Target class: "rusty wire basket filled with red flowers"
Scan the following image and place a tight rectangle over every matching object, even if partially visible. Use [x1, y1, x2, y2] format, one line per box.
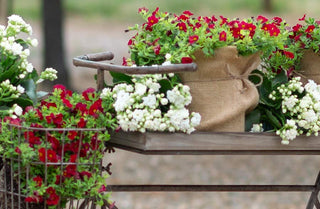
[0, 125, 110, 209]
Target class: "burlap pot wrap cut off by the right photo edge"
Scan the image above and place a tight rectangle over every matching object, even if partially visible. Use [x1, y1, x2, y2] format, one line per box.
[296, 50, 320, 84]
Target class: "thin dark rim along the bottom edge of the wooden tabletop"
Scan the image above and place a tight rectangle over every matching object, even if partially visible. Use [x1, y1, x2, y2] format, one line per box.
[108, 142, 320, 155]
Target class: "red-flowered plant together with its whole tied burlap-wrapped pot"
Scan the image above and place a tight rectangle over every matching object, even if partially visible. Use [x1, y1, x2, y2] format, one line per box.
[124, 8, 289, 131]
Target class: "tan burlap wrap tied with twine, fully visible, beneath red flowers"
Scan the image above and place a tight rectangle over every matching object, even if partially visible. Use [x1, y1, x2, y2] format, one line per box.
[180, 47, 260, 132]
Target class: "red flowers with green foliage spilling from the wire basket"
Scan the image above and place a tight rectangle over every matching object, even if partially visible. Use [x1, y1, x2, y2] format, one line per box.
[0, 85, 116, 208]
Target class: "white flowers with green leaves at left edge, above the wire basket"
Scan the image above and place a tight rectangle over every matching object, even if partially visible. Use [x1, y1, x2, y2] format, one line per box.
[0, 15, 57, 117]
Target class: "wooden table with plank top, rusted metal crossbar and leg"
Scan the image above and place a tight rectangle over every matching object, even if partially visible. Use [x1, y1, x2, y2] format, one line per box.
[108, 132, 320, 209]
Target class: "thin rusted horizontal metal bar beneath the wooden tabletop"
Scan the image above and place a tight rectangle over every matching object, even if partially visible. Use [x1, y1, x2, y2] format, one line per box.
[107, 184, 315, 192]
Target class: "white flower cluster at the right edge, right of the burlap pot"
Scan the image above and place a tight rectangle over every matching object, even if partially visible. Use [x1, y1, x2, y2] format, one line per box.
[269, 77, 320, 144]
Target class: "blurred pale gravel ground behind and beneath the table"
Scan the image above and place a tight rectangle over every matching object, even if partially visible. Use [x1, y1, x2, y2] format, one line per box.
[28, 19, 320, 209]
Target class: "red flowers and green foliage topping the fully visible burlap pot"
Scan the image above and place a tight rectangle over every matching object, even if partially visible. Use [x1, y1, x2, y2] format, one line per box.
[125, 8, 289, 66]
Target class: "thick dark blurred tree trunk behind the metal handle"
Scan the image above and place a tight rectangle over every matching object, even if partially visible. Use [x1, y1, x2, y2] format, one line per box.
[42, 0, 70, 90]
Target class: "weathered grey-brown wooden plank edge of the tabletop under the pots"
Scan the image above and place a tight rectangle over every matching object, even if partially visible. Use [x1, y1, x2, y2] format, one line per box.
[110, 132, 320, 154]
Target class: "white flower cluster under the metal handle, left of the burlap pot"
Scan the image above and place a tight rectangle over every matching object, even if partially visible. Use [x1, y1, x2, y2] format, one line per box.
[101, 74, 201, 133]
